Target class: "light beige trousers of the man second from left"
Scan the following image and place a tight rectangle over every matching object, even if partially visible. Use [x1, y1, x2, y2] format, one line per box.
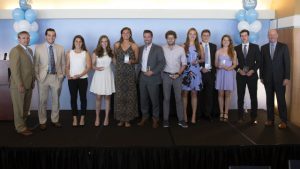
[38, 74, 62, 124]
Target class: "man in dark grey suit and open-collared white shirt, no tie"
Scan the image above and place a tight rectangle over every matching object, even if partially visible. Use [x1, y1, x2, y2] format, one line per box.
[138, 30, 166, 128]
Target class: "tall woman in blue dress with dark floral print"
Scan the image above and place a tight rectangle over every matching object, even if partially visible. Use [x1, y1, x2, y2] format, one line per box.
[182, 28, 204, 124]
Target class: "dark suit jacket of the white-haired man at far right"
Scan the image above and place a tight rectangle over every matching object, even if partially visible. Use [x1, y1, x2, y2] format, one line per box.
[260, 42, 290, 84]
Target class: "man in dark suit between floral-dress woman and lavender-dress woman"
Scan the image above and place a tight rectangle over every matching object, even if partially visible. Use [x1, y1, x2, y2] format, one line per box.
[198, 29, 219, 121]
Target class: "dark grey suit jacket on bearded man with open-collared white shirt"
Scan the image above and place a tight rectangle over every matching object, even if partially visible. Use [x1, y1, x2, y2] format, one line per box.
[138, 43, 166, 84]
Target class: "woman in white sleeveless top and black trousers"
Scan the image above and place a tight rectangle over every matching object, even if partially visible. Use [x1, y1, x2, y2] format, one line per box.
[66, 35, 91, 127]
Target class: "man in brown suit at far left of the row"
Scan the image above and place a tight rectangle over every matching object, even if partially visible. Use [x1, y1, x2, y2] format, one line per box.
[9, 31, 35, 136]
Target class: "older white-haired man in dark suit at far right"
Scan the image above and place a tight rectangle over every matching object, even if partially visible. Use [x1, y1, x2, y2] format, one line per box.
[260, 29, 290, 129]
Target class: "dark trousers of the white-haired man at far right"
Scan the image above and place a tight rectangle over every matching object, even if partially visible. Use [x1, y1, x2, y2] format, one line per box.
[264, 79, 287, 123]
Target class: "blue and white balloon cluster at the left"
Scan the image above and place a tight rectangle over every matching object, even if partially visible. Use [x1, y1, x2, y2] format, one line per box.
[12, 0, 39, 45]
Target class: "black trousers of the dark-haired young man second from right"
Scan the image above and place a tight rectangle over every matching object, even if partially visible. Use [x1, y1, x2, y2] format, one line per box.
[236, 73, 258, 119]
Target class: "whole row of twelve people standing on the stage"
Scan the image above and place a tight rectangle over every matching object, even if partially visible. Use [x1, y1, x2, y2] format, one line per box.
[10, 27, 290, 136]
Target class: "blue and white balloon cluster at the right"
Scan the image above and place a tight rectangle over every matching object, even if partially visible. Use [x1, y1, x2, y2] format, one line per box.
[234, 0, 262, 43]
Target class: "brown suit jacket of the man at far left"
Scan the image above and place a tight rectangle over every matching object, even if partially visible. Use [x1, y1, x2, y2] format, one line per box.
[9, 45, 35, 89]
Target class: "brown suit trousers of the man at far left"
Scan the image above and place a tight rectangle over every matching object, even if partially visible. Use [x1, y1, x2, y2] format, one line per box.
[10, 88, 32, 132]
